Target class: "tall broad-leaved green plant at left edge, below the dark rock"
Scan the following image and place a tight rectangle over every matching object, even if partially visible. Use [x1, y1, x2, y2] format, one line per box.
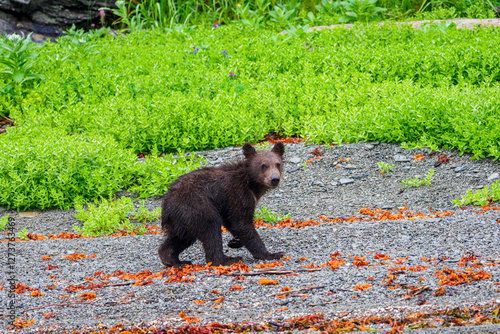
[0, 34, 44, 91]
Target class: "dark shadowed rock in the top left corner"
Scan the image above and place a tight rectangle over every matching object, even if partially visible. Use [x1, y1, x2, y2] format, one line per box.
[0, 0, 115, 42]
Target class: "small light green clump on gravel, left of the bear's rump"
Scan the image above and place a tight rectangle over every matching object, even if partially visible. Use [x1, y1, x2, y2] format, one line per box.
[73, 197, 134, 236]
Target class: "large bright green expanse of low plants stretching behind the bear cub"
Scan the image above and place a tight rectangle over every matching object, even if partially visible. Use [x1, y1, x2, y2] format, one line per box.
[14, 26, 500, 158]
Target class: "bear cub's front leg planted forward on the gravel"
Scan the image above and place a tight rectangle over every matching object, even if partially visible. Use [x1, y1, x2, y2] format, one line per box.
[229, 223, 285, 260]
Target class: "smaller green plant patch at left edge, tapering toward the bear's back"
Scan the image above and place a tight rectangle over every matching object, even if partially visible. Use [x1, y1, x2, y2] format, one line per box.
[0, 127, 201, 209]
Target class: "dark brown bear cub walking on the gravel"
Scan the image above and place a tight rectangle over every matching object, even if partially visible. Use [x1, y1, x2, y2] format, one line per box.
[158, 142, 285, 266]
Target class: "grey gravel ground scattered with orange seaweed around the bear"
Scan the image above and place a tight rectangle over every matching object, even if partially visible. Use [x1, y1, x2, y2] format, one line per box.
[0, 143, 500, 333]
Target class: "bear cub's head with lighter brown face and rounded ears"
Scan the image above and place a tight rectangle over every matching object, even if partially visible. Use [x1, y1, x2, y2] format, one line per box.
[243, 142, 285, 189]
